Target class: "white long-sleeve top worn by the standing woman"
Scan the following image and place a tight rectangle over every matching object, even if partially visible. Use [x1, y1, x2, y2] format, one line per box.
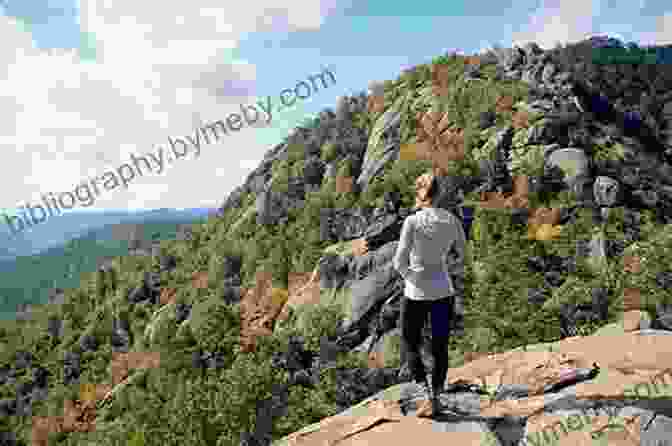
[392, 208, 466, 300]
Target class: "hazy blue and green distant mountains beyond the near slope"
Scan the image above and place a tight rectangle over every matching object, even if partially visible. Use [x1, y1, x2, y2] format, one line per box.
[0, 208, 216, 319]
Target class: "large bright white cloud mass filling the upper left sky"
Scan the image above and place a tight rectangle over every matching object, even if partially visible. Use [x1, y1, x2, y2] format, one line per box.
[0, 0, 334, 213]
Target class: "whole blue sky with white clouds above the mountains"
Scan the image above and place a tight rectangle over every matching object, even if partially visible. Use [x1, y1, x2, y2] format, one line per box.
[0, 0, 672, 219]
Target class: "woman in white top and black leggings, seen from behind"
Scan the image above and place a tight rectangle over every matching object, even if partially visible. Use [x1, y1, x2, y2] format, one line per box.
[393, 173, 466, 414]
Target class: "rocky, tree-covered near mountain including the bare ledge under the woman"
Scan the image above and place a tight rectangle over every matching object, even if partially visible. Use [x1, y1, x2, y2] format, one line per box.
[0, 35, 672, 446]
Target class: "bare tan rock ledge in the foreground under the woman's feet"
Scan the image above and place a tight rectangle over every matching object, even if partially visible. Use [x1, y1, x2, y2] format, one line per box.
[274, 330, 672, 446]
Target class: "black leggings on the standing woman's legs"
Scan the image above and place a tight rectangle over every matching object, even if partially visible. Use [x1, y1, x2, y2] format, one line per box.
[401, 296, 455, 389]
